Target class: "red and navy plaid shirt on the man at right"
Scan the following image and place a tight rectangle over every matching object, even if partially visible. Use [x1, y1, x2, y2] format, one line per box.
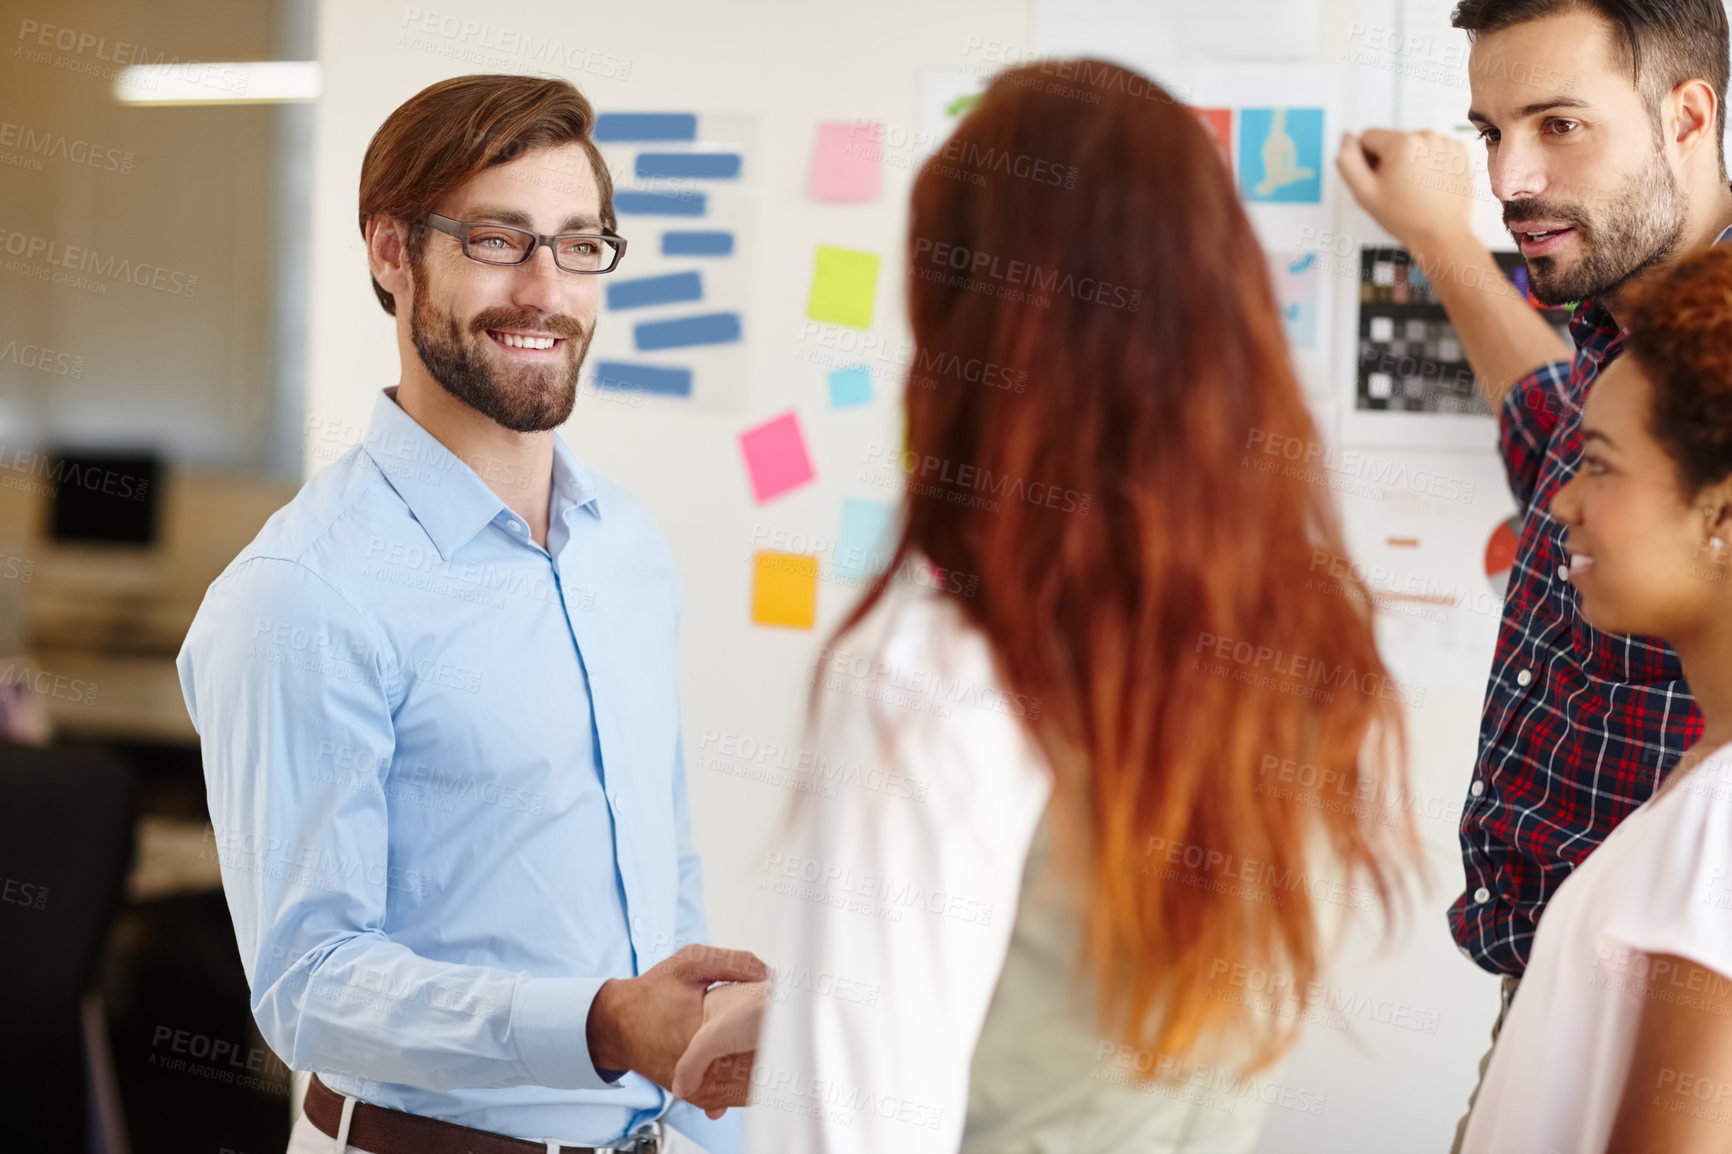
[1450, 229, 1732, 976]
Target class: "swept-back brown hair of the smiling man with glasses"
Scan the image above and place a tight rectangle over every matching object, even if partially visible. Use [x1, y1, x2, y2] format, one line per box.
[360, 75, 615, 317]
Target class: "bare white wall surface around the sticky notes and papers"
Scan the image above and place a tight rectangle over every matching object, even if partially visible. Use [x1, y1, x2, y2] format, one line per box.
[307, 0, 1509, 1154]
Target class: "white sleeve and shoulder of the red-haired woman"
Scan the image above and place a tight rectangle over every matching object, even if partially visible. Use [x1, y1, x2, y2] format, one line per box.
[748, 587, 1051, 1154]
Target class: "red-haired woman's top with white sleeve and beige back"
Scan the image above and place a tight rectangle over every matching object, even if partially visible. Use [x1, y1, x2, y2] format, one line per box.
[748, 589, 1268, 1154]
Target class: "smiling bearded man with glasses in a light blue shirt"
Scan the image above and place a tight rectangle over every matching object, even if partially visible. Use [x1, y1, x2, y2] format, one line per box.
[178, 76, 767, 1154]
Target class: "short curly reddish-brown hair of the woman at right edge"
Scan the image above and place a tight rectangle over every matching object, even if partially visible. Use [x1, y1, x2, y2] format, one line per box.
[1618, 244, 1732, 499]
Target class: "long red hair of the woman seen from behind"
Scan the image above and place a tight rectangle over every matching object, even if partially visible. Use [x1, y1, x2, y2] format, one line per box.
[837, 61, 1417, 1069]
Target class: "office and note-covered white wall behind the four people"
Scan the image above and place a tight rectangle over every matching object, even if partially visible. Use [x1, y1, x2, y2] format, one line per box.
[10, 0, 1718, 1154]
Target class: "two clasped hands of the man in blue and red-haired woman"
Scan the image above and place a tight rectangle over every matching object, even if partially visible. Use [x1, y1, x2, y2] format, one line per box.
[585, 946, 769, 1118]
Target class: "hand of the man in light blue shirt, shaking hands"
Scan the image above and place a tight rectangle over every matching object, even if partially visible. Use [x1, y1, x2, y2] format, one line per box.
[585, 946, 769, 1109]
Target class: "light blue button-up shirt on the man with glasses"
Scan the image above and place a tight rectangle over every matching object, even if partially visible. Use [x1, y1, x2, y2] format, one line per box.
[178, 390, 740, 1152]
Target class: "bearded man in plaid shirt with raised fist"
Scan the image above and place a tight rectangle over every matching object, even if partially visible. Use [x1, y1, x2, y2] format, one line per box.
[1335, 0, 1732, 1145]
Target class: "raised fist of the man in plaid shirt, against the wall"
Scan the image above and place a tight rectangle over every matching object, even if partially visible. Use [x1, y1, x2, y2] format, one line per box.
[1335, 128, 1474, 253]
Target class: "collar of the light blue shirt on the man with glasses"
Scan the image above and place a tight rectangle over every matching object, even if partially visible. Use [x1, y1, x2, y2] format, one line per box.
[362, 385, 601, 561]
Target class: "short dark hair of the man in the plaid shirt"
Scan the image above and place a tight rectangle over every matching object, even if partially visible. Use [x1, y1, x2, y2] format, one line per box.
[1450, 0, 1729, 177]
